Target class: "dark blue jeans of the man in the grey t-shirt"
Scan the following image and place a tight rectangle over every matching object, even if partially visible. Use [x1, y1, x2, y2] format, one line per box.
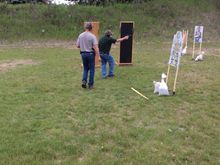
[80, 52, 95, 86]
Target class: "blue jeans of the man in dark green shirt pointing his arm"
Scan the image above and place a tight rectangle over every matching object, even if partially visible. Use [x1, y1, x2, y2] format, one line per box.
[100, 53, 115, 78]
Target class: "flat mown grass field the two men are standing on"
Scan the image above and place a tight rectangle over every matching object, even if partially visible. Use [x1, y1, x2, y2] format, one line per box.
[0, 41, 220, 165]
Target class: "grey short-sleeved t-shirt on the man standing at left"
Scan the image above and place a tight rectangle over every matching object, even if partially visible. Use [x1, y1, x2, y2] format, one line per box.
[76, 31, 98, 52]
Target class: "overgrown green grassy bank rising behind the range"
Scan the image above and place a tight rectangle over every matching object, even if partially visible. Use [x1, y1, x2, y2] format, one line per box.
[0, 0, 220, 42]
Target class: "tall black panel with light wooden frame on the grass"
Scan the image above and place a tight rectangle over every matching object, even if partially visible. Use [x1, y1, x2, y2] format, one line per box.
[119, 21, 134, 65]
